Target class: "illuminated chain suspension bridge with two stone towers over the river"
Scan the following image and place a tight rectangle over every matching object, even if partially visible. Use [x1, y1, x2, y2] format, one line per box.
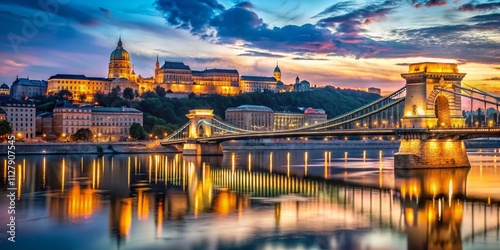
[161, 62, 500, 169]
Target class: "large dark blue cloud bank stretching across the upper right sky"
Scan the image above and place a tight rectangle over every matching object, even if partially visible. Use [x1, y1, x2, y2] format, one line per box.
[156, 0, 500, 63]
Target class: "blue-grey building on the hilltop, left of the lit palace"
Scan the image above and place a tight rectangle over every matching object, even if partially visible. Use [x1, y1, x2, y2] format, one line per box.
[10, 77, 47, 100]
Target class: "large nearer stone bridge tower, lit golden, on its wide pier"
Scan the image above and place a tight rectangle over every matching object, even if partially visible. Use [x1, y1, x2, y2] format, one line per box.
[394, 62, 470, 169]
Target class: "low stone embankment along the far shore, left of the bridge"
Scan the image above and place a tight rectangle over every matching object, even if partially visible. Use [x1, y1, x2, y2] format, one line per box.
[0, 141, 177, 155]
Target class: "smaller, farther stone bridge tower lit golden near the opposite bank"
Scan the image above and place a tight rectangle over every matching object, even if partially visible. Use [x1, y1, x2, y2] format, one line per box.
[183, 109, 222, 155]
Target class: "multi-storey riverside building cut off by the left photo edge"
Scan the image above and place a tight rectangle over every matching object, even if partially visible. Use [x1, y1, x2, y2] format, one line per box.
[0, 95, 36, 139]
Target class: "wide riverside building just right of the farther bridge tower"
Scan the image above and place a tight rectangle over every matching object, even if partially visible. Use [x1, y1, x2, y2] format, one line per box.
[225, 105, 274, 131]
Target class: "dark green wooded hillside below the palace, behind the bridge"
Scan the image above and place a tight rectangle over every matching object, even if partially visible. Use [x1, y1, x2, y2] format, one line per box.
[131, 88, 380, 131]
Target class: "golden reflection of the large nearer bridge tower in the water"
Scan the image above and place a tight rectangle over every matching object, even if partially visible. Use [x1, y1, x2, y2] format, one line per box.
[395, 168, 469, 249]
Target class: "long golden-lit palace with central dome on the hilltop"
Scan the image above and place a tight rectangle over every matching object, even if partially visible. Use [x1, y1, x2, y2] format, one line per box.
[47, 38, 310, 98]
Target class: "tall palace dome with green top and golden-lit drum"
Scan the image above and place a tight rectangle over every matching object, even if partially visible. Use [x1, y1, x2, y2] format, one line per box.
[108, 37, 131, 79]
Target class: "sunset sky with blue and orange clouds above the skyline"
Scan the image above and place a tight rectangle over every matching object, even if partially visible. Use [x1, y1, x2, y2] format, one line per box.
[0, 0, 500, 94]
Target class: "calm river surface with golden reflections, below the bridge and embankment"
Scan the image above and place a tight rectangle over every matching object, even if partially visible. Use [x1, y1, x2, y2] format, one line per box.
[0, 150, 500, 249]
